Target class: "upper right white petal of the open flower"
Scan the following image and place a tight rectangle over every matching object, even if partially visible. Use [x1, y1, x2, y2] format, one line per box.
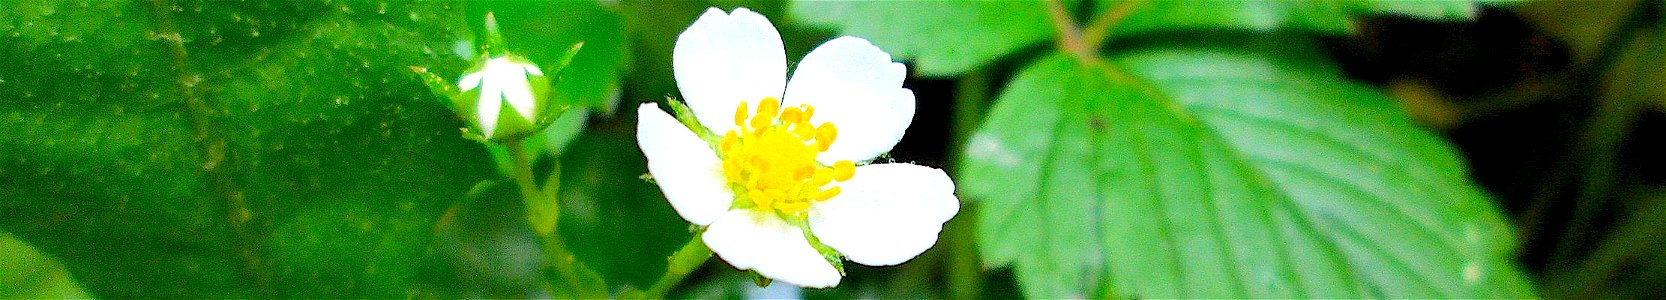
[781, 37, 915, 165]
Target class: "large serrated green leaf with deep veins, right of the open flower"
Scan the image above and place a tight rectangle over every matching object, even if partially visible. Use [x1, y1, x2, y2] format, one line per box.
[958, 38, 1533, 298]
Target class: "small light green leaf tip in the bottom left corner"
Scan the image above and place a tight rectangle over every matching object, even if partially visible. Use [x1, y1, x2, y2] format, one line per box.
[0, 232, 90, 298]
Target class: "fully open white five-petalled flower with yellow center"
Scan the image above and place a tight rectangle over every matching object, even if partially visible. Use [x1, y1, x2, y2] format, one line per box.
[636, 8, 960, 287]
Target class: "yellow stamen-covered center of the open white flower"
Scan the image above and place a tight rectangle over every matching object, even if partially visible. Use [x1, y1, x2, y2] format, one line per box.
[721, 98, 856, 215]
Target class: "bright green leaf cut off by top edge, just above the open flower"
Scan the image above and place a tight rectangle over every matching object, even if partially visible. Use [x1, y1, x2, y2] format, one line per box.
[791, 2, 1056, 77]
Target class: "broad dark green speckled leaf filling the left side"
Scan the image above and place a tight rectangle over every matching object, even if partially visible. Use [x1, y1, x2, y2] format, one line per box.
[0, 0, 495, 298]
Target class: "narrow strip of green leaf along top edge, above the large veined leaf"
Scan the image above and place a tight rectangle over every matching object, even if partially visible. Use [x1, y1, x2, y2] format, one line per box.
[1096, 0, 1479, 37]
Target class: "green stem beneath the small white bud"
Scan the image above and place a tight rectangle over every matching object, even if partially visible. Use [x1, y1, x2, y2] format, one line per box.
[503, 138, 606, 298]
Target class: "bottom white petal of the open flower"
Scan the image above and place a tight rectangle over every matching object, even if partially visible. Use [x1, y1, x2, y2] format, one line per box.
[701, 210, 840, 288]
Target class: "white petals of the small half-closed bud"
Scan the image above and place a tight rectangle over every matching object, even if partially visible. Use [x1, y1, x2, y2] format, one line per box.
[456, 57, 543, 138]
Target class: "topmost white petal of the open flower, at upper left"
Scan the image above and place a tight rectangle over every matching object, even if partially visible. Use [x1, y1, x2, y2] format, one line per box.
[671, 8, 786, 135]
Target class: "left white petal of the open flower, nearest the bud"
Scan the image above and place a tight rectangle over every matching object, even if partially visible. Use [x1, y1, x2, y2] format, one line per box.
[636, 103, 735, 225]
